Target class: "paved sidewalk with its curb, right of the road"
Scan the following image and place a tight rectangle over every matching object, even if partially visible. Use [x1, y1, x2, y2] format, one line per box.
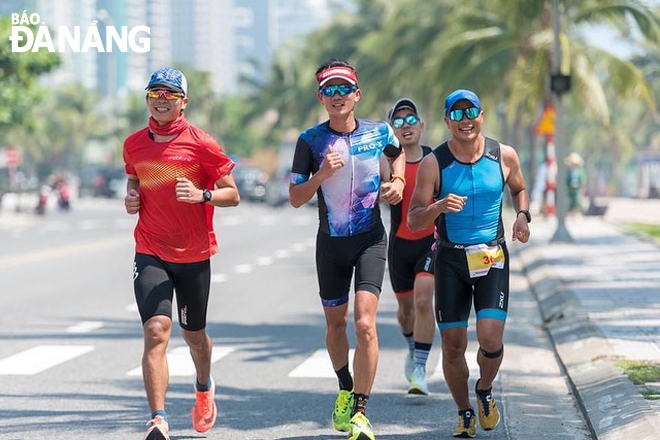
[516, 217, 660, 440]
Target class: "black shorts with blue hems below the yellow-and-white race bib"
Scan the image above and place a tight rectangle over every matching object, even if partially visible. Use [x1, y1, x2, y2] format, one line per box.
[435, 243, 509, 330]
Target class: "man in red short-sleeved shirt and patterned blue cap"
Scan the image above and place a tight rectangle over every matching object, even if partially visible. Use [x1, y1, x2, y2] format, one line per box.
[124, 67, 240, 440]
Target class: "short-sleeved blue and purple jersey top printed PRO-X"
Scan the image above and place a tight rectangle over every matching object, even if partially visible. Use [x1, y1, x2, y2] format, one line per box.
[291, 119, 401, 237]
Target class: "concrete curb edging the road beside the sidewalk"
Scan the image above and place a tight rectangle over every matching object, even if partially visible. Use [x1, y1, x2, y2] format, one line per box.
[517, 244, 660, 440]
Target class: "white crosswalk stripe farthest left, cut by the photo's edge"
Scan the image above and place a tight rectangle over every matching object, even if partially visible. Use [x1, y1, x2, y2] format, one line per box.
[0, 345, 94, 376]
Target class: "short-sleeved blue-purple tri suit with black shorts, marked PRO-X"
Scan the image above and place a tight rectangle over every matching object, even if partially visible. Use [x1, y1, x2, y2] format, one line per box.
[291, 119, 401, 307]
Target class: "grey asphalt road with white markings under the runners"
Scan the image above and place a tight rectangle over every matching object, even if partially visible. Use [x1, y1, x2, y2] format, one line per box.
[0, 200, 590, 440]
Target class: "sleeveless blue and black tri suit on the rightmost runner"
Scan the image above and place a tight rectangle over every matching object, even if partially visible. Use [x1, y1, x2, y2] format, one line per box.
[433, 138, 509, 330]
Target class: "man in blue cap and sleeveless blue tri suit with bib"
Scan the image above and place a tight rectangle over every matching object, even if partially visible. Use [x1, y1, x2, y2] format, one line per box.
[408, 89, 531, 437]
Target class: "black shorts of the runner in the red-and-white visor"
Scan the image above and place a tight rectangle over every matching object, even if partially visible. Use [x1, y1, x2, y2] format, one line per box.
[316, 223, 387, 307]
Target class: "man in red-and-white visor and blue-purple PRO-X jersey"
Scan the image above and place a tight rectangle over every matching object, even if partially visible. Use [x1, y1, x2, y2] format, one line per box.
[289, 59, 406, 440]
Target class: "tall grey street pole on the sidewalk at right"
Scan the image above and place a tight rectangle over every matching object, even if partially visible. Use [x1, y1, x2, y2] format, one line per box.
[551, 0, 573, 242]
